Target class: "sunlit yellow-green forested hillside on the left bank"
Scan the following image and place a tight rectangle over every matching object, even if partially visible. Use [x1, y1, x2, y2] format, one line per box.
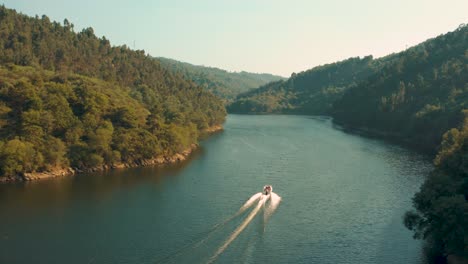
[0, 6, 226, 179]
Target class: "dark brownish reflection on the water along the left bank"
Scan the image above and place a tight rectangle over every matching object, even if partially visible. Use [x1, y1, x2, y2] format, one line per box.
[0, 146, 204, 212]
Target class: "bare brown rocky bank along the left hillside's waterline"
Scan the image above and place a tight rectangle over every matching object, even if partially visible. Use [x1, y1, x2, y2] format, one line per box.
[0, 125, 223, 183]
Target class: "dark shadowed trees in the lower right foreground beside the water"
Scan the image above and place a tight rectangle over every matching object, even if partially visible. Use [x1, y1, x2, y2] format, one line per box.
[404, 112, 468, 261]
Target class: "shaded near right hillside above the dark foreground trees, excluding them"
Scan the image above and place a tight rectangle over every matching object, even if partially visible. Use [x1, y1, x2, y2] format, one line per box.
[332, 26, 468, 153]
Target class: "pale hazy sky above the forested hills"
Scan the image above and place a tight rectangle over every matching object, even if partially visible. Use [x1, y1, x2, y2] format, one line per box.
[0, 0, 468, 76]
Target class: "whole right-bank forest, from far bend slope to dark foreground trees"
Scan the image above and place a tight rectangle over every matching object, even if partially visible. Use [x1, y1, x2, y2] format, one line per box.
[228, 25, 468, 257]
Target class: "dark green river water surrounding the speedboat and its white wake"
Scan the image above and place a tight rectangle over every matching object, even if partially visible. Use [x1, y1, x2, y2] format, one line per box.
[0, 115, 431, 264]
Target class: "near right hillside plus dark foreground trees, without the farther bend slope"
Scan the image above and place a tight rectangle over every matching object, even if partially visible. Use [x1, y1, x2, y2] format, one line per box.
[333, 25, 468, 257]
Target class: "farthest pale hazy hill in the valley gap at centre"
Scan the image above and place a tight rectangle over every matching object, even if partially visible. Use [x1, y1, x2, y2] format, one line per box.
[158, 58, 284, 102]
